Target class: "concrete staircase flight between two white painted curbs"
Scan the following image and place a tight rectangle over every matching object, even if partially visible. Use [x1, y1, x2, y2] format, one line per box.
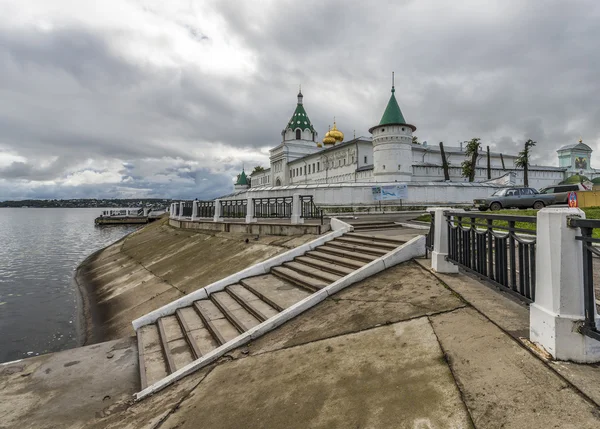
[137, 233, 404, 390]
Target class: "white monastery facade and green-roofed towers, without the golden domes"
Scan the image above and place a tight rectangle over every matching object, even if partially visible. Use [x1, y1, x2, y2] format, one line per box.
[239, 88, 600, 202]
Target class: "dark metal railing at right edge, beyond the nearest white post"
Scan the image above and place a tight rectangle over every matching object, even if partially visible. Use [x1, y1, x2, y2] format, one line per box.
[567, 217, 600, 341]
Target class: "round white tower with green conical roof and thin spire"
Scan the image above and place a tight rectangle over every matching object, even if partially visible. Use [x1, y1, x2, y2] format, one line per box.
[369, 73, 417, 183]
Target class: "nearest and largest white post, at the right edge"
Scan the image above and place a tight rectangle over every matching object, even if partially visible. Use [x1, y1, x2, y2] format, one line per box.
[529, 207, 600, 363]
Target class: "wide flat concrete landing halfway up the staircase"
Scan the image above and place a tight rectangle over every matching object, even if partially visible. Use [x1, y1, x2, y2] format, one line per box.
[240, 274, 311, 311]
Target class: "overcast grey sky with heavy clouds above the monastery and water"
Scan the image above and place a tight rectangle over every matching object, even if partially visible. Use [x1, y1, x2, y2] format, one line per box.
[0, 0, 600, 200]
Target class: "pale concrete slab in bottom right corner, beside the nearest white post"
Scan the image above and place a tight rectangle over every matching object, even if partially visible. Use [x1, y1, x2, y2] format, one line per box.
[430, 308, 600, 429]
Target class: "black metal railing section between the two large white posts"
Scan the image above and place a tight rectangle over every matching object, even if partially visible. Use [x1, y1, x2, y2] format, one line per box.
[444, 211, 537, 303]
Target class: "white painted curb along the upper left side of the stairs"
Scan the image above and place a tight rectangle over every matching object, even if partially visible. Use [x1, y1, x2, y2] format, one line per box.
[131, 219, 354, 331]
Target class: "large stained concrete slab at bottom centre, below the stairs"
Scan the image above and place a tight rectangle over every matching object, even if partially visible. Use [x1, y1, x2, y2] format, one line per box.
[161, 318, 472, 429]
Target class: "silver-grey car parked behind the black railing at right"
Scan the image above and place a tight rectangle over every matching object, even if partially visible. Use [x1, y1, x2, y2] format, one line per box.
[473, 188, 556, 211]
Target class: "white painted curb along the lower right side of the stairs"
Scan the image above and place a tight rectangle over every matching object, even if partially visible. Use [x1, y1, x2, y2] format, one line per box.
[135, 232, 425, 401]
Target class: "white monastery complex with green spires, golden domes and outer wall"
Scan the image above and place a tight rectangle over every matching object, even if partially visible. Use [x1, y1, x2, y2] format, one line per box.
[225, 81, 600, 204]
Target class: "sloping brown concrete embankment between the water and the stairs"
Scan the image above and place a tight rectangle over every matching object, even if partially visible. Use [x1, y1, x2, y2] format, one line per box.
[76, 219, 314, 344]
